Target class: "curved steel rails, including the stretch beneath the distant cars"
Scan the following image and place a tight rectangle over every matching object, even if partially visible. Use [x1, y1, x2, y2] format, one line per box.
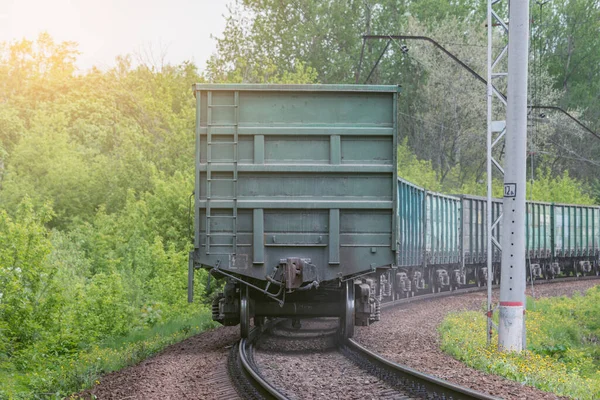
[230, 276, 598, 399]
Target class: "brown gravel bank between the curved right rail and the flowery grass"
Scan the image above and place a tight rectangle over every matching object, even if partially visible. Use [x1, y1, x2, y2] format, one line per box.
[355, 280, 598, 399]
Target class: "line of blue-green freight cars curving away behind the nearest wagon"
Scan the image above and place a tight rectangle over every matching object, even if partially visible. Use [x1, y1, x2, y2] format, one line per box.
[394, 179, 600, 297]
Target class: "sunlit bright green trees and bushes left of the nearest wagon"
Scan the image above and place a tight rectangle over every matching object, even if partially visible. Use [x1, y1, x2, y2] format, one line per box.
[0, 35, 213, 398]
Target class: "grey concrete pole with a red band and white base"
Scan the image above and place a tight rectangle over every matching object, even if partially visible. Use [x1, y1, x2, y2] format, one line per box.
[498, 0, 529, 352]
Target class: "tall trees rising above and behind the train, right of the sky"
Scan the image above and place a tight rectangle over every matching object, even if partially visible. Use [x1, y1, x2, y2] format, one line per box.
[207, 0, 600, 199]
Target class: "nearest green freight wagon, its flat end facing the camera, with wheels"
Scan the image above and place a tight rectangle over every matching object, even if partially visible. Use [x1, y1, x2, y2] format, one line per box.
[188, 84, 399, 336]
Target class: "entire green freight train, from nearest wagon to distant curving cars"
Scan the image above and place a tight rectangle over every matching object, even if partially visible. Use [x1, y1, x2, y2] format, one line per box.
[188, 84, 600, 337]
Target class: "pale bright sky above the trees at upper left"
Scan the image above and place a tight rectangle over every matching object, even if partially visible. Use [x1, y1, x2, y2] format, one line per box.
[0, 0, 233, 72]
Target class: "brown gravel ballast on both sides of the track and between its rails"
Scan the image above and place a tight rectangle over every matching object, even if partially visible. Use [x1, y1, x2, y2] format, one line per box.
[82, 281, 597, 400]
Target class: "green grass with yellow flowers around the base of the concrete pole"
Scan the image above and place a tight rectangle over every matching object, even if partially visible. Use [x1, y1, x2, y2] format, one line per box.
[439, 286, 600, 399]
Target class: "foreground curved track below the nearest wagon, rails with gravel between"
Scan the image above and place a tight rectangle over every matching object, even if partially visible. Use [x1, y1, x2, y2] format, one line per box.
[230, 320, 495, 400]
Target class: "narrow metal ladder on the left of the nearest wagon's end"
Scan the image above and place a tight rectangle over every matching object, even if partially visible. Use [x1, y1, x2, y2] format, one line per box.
[205, 91, 239, 256]
